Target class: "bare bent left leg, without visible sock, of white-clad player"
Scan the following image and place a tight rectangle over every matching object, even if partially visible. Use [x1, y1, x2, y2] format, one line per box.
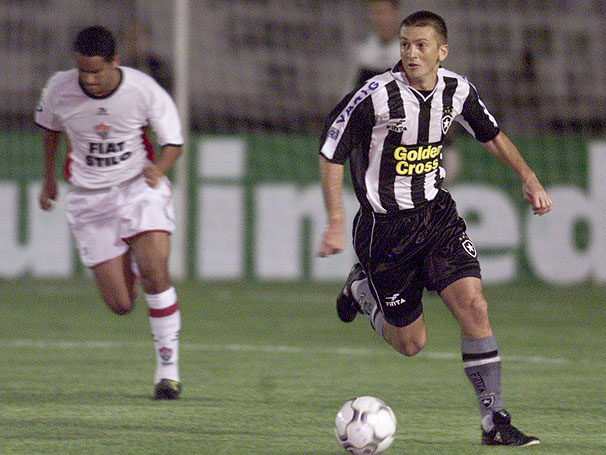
[92, 252, 136, 314]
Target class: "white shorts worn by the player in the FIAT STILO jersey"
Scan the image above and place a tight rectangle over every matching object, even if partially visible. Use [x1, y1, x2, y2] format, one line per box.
[67, 174, 175, 267]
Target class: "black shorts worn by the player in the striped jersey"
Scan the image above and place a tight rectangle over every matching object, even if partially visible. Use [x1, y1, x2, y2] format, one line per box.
[353, 190, 481, 327]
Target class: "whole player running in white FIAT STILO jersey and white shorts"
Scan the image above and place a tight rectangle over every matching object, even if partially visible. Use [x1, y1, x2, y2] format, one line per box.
[35, 26, 183, 400]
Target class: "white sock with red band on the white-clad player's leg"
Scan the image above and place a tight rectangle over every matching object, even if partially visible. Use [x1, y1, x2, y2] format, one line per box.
[145, 287, 181, 384]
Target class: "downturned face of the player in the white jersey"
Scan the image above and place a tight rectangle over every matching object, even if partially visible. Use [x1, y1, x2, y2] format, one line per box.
[76, 54, 120, 96]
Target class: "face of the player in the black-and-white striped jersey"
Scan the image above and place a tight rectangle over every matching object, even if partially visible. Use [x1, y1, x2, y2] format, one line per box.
[400, 26, 448, 90]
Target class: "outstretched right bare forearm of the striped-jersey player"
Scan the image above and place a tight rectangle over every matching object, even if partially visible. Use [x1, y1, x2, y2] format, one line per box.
[483, 132, 552, 215]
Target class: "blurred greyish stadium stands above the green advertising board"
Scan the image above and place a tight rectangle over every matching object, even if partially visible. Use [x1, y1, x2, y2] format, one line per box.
[0, 0, 606, 134]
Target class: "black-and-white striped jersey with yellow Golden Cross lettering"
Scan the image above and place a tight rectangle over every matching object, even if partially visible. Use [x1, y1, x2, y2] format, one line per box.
[320, 63, 499, 213]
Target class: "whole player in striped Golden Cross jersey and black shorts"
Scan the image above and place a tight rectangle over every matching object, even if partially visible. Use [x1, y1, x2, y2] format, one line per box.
[318, 11, 552, 446]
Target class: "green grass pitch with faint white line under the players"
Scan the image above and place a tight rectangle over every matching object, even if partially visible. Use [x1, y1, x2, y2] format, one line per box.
[0, 279, 606, 455]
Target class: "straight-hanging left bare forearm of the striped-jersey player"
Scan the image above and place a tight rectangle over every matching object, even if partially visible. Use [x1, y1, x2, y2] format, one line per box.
[318, 156, 345, 257]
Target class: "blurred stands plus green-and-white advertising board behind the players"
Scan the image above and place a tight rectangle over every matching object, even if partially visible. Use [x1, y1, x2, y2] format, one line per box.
[0, 0, 606, 283]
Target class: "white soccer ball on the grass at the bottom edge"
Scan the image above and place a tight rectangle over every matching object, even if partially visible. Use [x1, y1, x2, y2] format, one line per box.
[335, 397, 396, 455]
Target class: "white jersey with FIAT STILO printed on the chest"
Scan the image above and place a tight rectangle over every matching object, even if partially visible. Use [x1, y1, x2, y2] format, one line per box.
[35, 67, 183, 189]
